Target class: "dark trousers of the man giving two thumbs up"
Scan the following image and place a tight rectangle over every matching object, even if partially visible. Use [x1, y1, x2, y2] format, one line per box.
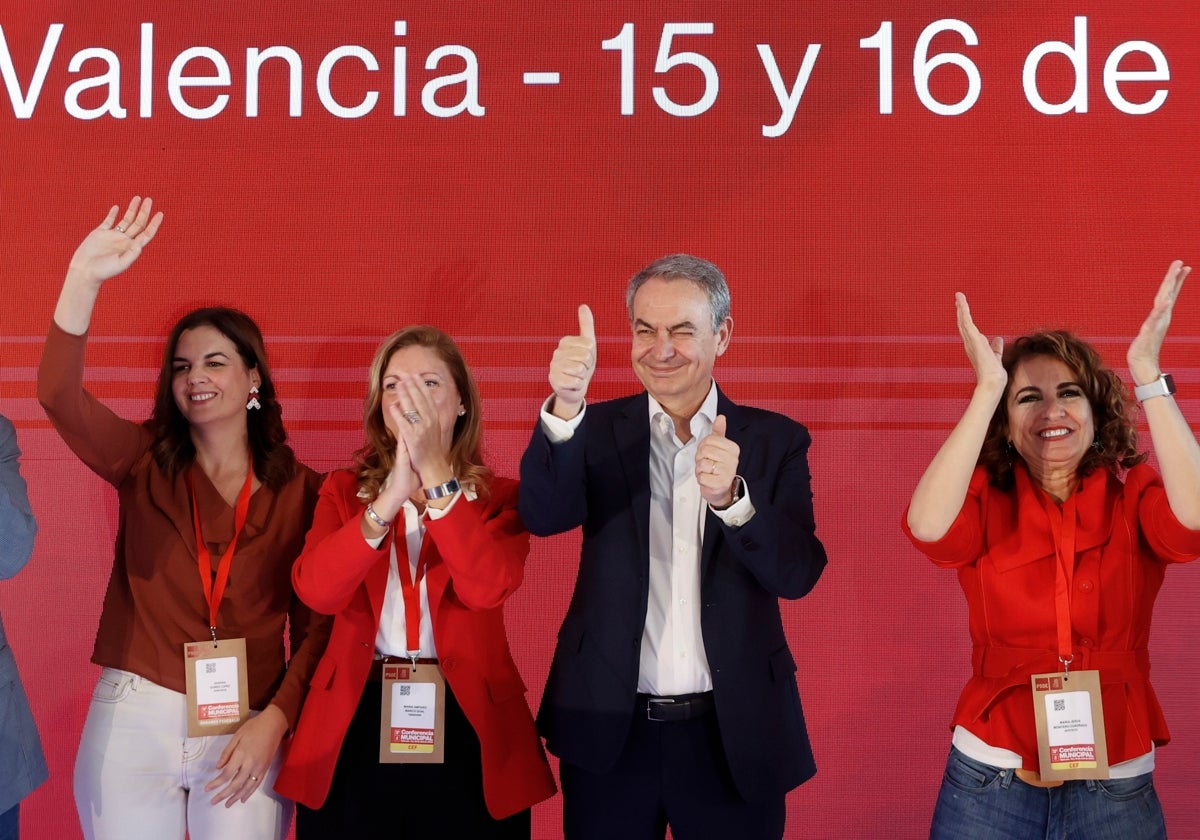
[559, 706, 786, 840]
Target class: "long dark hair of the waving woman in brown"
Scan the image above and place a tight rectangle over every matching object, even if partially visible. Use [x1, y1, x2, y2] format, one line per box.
[144, 306, 296, 491]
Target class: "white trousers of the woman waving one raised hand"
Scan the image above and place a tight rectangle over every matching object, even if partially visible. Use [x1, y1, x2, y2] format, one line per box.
[74, 668, 293, 840]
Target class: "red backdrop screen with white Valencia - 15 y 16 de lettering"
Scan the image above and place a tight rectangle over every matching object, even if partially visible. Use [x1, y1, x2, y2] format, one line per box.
[0, 0, 1200, 839]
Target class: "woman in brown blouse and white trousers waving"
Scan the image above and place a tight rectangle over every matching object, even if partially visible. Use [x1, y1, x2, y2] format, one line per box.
[37, 198, 328, 840]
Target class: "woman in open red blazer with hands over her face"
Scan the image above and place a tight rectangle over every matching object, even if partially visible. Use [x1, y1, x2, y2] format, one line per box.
[276, 326, 556, 840]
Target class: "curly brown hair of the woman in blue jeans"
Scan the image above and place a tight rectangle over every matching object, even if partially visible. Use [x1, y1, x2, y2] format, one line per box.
[978, 330, 1146, 490]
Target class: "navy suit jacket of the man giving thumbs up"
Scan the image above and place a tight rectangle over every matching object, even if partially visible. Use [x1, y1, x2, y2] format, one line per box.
[518, 392, 826, 799]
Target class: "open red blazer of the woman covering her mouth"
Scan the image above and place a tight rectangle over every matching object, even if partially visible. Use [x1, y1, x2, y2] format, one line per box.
[275, 470, 556, 820]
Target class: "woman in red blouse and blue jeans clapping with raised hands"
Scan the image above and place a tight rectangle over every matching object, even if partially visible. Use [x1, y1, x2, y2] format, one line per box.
[904, 262, 1200, 840]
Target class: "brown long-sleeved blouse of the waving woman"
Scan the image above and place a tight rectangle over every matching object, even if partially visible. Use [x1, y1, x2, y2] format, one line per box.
[37, 324, 330, 726]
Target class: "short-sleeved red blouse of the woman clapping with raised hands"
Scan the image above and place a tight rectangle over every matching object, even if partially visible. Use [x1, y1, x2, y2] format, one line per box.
[901, 464, 1200, 770]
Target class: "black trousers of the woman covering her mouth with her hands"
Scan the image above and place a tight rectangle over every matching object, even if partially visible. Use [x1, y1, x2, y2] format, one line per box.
[296, 683, 530, 840]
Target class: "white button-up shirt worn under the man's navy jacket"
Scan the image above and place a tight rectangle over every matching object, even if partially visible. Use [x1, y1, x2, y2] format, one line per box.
[541, 383, 754, 696]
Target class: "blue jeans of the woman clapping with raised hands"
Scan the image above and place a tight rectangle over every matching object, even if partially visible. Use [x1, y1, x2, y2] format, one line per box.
[929, 748, 1166, 840]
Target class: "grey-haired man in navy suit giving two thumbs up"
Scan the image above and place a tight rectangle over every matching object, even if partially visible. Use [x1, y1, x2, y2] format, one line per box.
[520, 254, 826, 840]
